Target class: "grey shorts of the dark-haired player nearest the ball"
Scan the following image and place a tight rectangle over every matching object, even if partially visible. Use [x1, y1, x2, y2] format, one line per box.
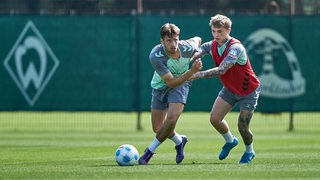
[151, 82, 191, 110]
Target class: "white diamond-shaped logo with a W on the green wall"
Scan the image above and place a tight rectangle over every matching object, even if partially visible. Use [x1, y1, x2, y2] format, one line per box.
[4, 21, 59, 106]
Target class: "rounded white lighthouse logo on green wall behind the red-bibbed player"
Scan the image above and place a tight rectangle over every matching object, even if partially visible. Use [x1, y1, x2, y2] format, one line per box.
[244, 29, 306, 98]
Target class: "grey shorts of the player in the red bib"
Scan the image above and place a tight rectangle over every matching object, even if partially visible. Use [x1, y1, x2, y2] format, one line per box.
[218, 86, 261, 111]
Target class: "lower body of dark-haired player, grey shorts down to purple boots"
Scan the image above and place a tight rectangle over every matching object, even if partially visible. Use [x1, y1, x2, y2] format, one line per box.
[139, 83, 189, 164]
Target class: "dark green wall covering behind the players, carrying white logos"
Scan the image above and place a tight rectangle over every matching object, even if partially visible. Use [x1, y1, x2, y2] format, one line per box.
[0, 16, 320, 112]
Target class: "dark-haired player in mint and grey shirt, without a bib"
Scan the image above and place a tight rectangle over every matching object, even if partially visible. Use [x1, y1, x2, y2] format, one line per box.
[139, 23, 202, 164]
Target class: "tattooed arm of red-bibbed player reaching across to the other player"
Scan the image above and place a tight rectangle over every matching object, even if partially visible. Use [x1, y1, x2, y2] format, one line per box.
[189, 61, 234, 80]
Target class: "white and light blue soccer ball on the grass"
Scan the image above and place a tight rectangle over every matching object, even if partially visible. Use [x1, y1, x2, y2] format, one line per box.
[116, 144, 139, 166]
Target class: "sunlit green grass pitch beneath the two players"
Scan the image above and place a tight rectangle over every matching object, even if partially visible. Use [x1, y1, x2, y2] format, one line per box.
[0, 112, 320, 179]
